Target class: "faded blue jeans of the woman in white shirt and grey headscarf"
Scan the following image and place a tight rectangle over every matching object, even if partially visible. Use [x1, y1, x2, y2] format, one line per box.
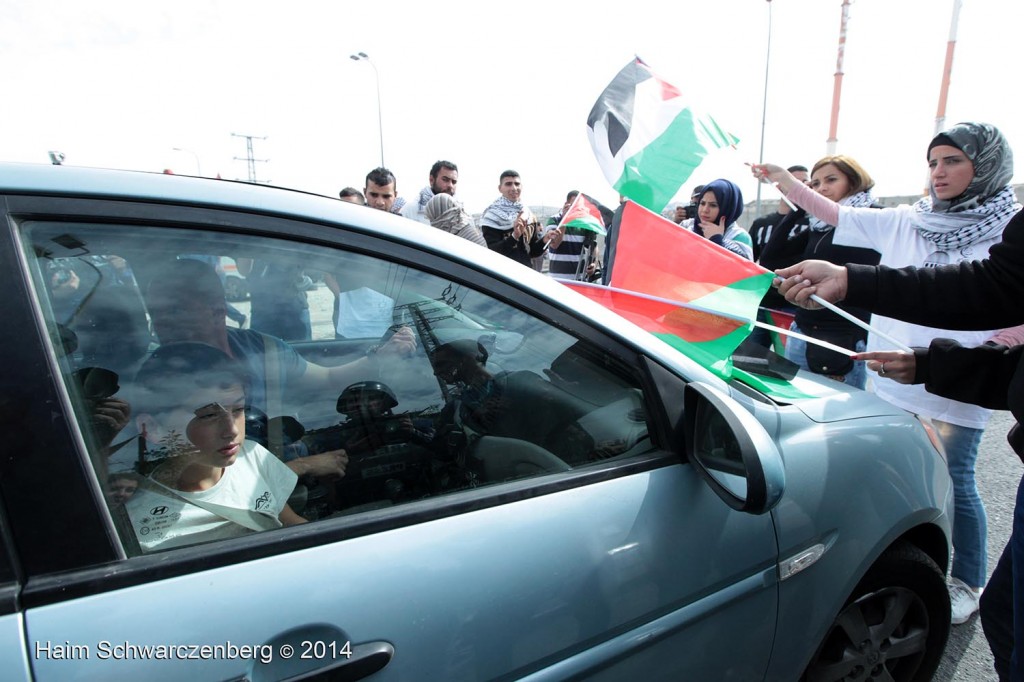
[932, 420, 988, 588]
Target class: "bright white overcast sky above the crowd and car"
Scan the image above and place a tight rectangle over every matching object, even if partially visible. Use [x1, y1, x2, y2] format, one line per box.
[0, 0, 1024, 212]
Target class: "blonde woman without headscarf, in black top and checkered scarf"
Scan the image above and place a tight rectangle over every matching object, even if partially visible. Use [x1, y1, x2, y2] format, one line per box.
[762, 156, 879, 388]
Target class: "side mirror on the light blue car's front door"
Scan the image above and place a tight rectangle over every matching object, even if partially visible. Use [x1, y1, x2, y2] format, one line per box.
[683, 382, 785, 514]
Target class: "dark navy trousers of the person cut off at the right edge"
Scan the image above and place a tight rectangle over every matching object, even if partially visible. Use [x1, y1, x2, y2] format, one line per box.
[981, 478, 1024, 682]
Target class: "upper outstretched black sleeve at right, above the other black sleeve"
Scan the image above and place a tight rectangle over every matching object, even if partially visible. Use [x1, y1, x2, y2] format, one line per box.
[846, 212, 1024, 330]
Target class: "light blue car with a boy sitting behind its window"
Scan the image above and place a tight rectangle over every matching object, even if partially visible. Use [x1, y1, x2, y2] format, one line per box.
[0, 166, 951, 682]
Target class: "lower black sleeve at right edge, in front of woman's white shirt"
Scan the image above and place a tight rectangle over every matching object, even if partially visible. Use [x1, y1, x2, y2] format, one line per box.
[914, 339, 1024, 410]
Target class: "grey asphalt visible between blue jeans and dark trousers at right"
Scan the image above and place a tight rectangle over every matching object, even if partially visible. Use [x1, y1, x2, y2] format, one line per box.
[934, 412, 1024, 682]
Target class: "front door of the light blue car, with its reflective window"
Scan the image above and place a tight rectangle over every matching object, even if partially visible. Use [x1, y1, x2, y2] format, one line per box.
[0, 189, 777, 680]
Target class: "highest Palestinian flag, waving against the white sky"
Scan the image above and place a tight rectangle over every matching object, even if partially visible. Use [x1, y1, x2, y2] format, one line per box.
[587, 57, 739, 212]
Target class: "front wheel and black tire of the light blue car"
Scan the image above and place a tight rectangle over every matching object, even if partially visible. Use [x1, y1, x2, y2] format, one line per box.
[803, 544, 950, 682]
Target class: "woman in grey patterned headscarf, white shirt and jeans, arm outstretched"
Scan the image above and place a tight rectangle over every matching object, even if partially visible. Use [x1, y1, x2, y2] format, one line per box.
[754, 123, 1021, 624]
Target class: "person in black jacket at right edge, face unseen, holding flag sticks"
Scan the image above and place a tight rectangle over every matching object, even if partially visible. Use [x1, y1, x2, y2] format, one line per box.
[777, 212, 1024, 681]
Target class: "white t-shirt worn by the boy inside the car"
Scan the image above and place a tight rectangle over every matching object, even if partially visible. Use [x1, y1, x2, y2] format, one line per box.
[125, 440, 298, 552]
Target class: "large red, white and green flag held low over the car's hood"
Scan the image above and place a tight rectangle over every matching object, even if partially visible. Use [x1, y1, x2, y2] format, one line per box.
[608, 202, 775, 376]
